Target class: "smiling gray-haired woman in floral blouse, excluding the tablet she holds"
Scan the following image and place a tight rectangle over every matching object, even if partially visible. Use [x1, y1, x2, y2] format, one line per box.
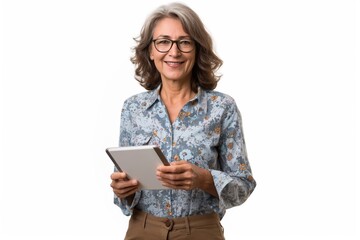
[111, 3, 256, 239]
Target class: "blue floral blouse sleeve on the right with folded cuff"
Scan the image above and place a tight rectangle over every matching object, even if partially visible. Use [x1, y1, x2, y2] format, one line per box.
[211, 102, 256, 209]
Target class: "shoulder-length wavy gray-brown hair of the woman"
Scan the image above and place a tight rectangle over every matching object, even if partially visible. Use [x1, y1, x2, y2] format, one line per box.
[130, 2, 223, 92]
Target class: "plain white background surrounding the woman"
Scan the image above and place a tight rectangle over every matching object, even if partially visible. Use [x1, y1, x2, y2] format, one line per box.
[0, 0, 360, 240]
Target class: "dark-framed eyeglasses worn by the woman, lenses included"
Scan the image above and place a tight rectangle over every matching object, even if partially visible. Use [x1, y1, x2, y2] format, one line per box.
[153, 38, 194, 53]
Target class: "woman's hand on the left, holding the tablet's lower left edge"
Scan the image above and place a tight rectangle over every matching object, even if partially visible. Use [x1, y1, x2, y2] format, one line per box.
[110, 172, 139, 200]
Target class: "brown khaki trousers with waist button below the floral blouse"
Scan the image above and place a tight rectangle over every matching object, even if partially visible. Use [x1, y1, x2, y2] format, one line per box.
[125, 210, 225, 240]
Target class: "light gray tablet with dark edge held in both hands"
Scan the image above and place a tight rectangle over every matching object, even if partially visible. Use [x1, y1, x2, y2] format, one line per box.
[106, 145, 170, 189]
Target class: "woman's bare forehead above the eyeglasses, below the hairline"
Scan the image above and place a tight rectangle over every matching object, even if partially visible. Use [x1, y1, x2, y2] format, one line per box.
[154, 17, 189, 38]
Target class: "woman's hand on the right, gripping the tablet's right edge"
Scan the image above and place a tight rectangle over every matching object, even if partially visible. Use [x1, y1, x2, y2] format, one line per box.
[156, 160, 217, 196]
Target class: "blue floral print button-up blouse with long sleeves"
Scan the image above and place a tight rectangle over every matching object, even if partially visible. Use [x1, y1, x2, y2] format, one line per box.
[114, 86, 256, 219]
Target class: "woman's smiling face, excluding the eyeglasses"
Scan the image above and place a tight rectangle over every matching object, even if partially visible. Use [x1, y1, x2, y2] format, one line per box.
[150, 18, 195, 82]
